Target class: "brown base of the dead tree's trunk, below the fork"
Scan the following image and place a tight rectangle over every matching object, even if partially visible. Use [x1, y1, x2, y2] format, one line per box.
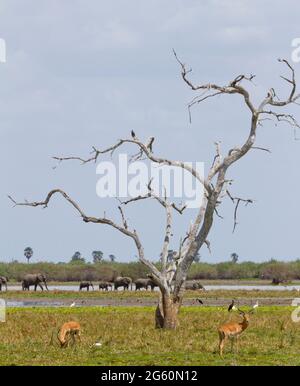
[155, 292, 182, 330]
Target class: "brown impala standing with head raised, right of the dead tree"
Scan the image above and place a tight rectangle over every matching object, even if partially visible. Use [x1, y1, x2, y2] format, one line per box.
[218, 302, 258, 356]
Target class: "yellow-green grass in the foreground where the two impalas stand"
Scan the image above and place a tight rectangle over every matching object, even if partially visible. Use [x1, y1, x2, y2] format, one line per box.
[0, 307, 300, 366]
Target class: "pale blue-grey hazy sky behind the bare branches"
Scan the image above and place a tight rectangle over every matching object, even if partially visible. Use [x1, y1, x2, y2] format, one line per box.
[0, 0, 300, 262]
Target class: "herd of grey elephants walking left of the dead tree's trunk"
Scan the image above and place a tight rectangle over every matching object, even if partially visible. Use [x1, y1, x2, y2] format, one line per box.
[0, 273, 156, 291]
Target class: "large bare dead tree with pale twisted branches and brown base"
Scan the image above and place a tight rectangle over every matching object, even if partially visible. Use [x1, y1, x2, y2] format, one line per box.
[10, 52, 300, 329]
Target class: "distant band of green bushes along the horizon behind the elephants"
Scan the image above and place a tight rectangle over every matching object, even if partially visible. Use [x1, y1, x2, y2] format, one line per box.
[0, 253, 300, 281]
